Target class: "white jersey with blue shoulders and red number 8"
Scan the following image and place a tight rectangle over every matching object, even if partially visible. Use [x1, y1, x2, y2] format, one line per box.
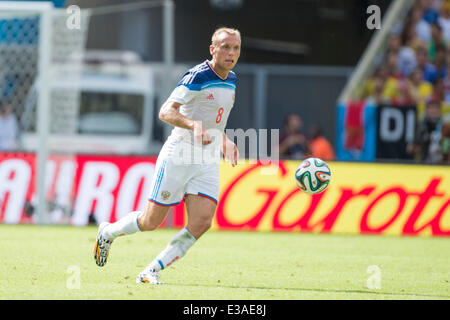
[163, 60, 237, 162]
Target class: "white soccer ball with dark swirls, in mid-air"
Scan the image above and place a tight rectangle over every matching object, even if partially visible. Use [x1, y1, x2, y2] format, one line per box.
[295, 158, 331, 194]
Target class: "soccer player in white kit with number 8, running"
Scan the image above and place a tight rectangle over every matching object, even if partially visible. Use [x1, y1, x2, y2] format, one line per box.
[94, 28, 241, 284]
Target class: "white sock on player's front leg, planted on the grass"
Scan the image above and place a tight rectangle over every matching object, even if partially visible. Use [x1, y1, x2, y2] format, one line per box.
[145, 228, 197, 271]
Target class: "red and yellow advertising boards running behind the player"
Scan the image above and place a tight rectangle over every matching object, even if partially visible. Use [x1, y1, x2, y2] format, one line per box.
[0, 153, 450, 236]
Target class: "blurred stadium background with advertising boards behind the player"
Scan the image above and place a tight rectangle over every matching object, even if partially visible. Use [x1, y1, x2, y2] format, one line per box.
[0, 0, 450, 300]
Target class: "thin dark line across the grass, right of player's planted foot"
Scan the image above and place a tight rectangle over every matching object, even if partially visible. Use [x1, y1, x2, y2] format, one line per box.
[165, 282, 450, 299]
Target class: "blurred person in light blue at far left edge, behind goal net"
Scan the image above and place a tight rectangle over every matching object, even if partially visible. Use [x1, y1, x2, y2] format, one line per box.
[0, 102, 19, 151]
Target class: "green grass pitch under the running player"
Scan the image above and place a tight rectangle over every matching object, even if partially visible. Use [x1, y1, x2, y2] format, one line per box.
[0, 225, 450, 300]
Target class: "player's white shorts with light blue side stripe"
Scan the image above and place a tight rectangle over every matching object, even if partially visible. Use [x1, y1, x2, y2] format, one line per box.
[148, 157, 219, 206]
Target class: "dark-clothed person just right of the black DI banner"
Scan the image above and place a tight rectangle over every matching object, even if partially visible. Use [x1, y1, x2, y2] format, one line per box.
[408, 99, 442, 163]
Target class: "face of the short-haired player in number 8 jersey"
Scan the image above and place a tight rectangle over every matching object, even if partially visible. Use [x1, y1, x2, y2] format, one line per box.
[210, 32, 241, 71]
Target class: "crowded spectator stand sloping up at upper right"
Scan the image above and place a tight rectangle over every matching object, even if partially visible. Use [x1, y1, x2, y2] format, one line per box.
[362, 0, 450, 163]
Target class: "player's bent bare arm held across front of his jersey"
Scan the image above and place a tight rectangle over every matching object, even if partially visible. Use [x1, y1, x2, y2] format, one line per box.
[159, 101, 212, 145]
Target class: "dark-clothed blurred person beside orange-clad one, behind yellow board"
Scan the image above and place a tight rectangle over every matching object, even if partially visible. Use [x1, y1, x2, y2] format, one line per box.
[278, 113, 308, 159]
